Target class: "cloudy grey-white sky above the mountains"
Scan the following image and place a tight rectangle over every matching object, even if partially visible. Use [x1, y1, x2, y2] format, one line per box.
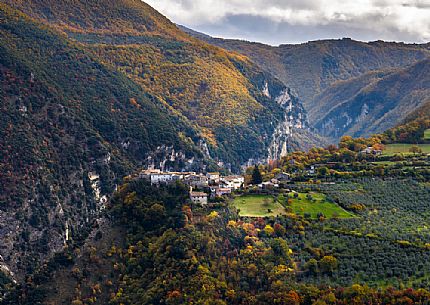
[144, 0, 430, 45]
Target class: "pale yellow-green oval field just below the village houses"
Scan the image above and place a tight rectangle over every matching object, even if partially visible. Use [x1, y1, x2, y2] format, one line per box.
[232, 195, 286, 217]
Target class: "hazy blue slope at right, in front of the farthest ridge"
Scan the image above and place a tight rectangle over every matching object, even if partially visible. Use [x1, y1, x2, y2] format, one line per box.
[313, 59, 430, 138]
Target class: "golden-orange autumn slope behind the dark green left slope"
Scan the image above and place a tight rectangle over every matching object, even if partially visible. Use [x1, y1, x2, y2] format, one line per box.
[1, 0, 326, 169]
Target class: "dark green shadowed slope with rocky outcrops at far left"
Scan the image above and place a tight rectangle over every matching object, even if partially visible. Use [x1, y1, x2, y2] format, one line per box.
[0, 4, 204, 278]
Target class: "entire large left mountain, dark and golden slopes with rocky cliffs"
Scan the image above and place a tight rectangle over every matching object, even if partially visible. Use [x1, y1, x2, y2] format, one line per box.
[0, 0, 328, 279]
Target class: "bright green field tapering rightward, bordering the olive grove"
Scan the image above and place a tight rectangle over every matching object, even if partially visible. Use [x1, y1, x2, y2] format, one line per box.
[289, 193, 354, 218]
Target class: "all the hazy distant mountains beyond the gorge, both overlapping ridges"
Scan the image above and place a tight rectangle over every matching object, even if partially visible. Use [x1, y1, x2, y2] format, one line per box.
[182, 27, 430, 141]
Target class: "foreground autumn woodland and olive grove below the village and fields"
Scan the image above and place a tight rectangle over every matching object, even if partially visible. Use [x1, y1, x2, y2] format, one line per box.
[3, 179, 430, 305]
